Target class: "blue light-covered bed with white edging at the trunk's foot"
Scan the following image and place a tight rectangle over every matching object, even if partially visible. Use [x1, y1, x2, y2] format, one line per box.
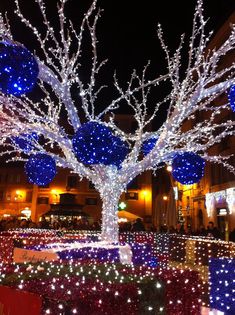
[22, 239, 154, 267]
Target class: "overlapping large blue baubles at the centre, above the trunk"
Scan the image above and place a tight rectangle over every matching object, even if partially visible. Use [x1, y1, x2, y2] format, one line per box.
[72, 121, 128, 167]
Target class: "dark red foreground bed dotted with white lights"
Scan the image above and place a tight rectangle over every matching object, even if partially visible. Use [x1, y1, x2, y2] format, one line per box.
[1, 262, 200, 315]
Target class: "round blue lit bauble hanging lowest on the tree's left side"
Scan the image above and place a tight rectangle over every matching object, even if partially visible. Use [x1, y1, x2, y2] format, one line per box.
[25, 153, 56, 186]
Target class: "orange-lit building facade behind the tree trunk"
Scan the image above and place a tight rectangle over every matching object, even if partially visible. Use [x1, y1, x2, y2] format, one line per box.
[0, 166, 152, 222]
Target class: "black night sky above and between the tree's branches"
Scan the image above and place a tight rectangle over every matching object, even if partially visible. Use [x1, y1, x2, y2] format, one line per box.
[0, 0, 235, 125]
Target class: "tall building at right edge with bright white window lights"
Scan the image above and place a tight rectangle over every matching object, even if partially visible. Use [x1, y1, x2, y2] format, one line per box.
[162, 12, 235, 239]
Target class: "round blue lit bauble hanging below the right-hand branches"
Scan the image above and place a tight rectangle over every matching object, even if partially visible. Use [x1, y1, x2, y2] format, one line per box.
[172, 152, 205, 185]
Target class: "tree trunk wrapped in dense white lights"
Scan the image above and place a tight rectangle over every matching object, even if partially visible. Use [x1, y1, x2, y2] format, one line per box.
[101, 188, 121, 244]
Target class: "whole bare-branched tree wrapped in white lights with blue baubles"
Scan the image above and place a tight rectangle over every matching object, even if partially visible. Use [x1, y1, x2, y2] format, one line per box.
[0, 0, 235, 243]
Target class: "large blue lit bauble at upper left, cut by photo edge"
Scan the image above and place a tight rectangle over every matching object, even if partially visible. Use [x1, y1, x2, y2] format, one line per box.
[0, 42, 39, 96]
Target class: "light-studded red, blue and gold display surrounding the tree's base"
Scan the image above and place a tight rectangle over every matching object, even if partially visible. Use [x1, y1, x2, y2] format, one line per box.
[0, 230, 235, 315]
